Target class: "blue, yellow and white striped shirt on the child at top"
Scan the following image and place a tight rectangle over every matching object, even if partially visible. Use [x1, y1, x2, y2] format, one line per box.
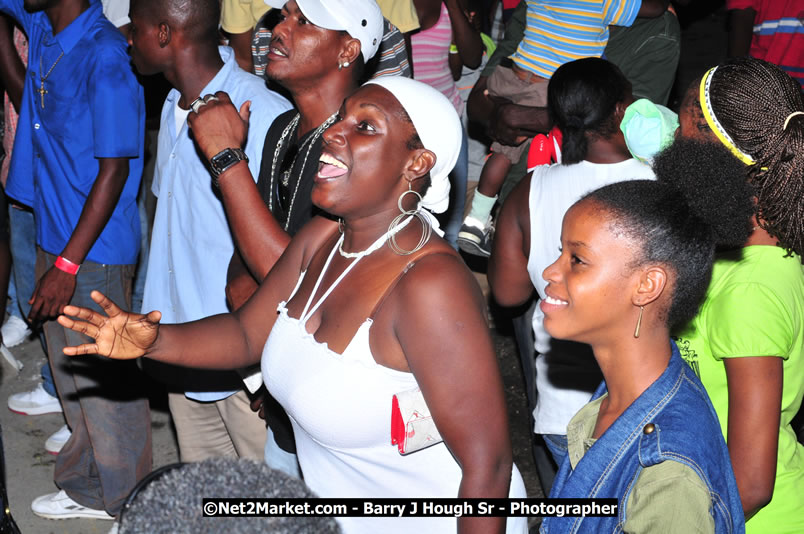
[511, 0, 642, 79]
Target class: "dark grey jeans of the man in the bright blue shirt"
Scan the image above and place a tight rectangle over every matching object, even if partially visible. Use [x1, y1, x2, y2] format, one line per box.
[36, 249, 151, 515]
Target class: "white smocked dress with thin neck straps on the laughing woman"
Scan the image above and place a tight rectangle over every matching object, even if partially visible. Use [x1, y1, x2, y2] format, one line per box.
[262, 242, 527, 534]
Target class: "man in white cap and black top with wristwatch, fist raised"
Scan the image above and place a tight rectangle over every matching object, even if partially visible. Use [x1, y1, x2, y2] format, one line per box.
[188, 0, 383, 476]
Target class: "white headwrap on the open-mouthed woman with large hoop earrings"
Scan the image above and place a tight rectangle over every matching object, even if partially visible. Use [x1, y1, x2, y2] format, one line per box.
[366, 76, 463, 218]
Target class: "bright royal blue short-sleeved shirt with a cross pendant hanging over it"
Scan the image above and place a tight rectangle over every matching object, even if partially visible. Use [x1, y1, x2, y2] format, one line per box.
[0, 0, 145, 264]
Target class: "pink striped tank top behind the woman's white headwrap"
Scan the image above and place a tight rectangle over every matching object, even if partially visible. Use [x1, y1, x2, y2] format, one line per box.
[410, 3, 463, 115]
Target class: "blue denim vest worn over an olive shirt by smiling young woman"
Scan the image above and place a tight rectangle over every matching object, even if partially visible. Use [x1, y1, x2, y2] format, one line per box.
[541, 342, 745, 534]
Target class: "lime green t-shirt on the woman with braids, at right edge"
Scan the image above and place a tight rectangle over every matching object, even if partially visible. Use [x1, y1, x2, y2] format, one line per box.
[675, 246, 804, 534]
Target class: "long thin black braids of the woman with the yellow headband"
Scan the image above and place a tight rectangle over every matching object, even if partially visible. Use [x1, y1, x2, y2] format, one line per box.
[710, 57, 804, 256]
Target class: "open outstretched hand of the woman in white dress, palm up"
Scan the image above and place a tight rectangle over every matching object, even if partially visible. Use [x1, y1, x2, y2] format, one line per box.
[58, 291, 162, 360]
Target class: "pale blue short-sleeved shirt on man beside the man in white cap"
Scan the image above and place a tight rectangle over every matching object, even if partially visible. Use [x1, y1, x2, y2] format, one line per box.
[142, 46, 290, 401]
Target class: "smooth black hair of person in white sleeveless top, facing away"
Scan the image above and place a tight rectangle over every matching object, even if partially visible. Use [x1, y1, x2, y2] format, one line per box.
[547, 57, 631, 165]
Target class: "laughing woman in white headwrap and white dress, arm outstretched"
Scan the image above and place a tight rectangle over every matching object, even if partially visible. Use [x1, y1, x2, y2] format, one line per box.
[60, 77, 527, 534]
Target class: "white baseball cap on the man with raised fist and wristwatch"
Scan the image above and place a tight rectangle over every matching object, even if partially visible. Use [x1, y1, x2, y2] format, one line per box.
[265, 0, 383, 61]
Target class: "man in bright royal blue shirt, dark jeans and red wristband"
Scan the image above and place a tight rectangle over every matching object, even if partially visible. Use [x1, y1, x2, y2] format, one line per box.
[0, 0, 151, 519]
